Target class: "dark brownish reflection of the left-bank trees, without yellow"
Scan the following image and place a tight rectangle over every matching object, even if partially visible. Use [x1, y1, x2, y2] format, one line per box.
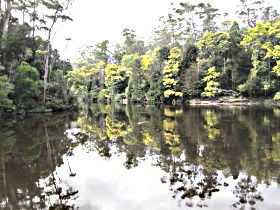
[0, 114, 77, 209]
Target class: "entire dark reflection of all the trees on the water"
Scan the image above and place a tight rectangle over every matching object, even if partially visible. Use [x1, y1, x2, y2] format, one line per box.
[0, 105, 280, 209]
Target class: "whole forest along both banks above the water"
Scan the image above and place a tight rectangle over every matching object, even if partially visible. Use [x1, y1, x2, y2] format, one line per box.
[0, 0, 280, 112]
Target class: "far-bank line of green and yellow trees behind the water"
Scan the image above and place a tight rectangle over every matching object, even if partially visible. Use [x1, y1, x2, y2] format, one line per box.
[67, 0, 280, 103]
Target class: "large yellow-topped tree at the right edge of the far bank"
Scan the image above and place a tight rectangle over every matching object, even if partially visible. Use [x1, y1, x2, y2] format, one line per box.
[239, 20, 280, 95]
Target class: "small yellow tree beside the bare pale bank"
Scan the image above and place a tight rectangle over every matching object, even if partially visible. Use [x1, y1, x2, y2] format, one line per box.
[202, 67, 220, 98]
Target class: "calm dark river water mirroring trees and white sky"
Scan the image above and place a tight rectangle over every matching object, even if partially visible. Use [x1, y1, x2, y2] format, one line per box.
[0, 106, 280, 210]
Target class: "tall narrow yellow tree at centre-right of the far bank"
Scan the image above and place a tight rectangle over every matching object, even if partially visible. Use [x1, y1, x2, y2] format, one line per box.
[163, 47, 183, 98]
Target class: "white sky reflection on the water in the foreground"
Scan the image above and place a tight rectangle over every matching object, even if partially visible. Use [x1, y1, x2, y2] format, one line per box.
[36, 143, 279, 210]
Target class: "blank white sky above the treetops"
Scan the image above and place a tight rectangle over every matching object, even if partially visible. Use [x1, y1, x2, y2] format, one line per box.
[54, 0, 279, 61]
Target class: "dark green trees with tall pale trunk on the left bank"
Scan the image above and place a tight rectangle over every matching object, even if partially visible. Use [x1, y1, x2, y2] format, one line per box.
[0, 0, 75, 112]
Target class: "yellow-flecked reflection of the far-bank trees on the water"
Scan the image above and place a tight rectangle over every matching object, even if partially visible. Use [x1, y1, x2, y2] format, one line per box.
[72, 106, 279, 206]
